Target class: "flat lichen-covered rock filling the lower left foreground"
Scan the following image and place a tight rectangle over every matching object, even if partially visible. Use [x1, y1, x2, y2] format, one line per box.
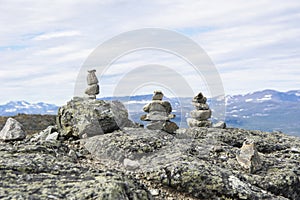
[0, 132, 152, 200]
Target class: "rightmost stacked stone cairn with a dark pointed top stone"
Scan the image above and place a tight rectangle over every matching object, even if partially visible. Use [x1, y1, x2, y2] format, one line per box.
[187, 92, 212, 127]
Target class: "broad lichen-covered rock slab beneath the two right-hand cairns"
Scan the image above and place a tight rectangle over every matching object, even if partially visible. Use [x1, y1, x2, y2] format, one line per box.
[83, 127, 300, 199]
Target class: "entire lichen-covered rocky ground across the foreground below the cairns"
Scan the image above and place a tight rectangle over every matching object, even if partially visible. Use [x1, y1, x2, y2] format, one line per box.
[0, 124, 300, 199]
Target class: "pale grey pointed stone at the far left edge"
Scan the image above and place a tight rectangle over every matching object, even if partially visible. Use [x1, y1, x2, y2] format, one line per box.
[0, 118, 26, 141]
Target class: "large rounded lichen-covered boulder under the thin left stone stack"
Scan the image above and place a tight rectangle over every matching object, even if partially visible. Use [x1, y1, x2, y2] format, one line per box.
[57, 97, 134, 138]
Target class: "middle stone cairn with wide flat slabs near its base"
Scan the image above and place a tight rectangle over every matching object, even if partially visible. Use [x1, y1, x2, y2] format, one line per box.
[141, 90, 178, 133]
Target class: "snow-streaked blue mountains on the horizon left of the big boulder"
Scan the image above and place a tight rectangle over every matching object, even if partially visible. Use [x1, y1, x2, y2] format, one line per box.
[0, 101, 58, 116]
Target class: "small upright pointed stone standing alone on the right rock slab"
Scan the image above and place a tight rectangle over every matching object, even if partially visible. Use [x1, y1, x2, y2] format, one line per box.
[236, 141, 261, 173]
